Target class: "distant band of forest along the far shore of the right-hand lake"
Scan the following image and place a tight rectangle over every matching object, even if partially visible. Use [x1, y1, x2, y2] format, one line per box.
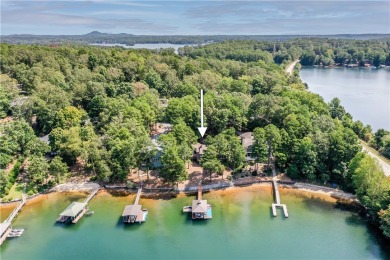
[181, 38, 390, 67]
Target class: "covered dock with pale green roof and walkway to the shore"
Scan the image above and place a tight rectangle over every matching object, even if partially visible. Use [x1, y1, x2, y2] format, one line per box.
[57, 188, 100, 224]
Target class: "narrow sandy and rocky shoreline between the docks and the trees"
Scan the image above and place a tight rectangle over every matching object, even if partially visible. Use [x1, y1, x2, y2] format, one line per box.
[0, 181, 361, 207]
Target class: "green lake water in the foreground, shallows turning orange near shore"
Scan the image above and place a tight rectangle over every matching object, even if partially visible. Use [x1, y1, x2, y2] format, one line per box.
[0, 186, 390, 260]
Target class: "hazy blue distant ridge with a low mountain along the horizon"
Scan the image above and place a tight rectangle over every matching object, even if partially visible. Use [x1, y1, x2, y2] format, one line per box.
[0, 31, 390, 45]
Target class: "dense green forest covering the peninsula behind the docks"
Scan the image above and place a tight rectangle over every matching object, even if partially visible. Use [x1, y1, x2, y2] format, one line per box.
[0, 39, 390, 237]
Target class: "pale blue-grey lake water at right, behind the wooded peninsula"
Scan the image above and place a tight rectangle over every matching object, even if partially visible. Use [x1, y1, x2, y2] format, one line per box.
[300, 67, 390, 131]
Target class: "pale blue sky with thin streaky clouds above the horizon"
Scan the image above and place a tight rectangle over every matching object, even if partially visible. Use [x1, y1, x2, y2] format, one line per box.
[0, 0, 390, 35]
